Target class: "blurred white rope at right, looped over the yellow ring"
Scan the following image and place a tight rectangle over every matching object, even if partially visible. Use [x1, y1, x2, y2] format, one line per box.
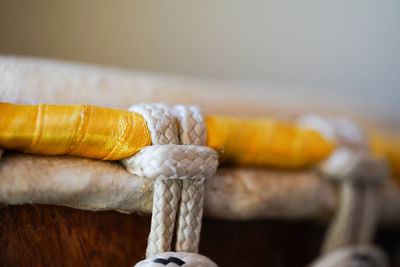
[297, 114, 386, 253]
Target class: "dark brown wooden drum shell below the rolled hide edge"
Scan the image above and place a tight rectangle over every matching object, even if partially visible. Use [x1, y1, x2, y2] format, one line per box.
[0, 205, 400, 267]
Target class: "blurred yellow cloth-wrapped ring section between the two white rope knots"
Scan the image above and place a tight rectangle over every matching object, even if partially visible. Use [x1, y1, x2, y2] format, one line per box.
[206, 116, 334, 168]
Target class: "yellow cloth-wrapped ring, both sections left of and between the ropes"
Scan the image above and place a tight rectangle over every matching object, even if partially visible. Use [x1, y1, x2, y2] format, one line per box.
[0, 103, 334, 167]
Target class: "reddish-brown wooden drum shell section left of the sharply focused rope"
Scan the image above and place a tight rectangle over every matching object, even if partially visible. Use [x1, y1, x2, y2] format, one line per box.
[0, 205, 150, 266]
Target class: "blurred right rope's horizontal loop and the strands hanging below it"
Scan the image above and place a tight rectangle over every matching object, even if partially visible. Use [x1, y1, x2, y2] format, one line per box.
[321, 148, 388, 253]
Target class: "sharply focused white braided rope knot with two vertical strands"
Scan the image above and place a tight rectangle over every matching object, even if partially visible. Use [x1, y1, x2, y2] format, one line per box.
[122, 104, 218, 257]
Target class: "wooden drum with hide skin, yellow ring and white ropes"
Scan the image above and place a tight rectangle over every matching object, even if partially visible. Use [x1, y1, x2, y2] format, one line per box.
[0, 58, 400, 266]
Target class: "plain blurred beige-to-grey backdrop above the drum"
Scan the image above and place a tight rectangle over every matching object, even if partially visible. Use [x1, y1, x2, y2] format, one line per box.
[0, 0, 400, 126]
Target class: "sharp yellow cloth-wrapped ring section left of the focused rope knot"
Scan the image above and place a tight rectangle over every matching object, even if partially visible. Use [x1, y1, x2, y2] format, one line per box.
[0, 103, 151, 160]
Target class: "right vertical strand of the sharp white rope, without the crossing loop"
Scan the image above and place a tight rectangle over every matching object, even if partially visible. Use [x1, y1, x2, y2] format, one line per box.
[173, 105, 208, 253]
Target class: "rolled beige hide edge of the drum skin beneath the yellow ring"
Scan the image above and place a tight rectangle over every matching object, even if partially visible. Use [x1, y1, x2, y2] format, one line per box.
[0, 152, 400, 225]
